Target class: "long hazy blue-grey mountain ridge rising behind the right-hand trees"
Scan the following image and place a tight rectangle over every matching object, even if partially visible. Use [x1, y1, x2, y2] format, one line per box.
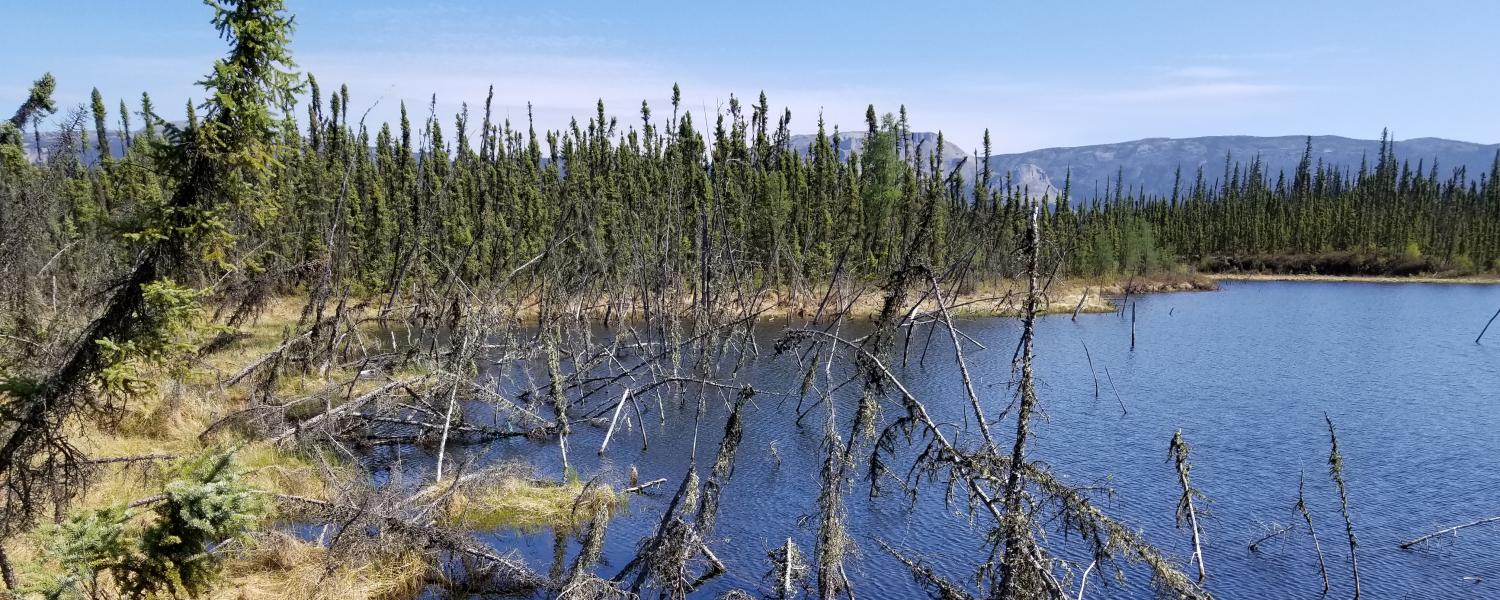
[965, 135, 1500, 200]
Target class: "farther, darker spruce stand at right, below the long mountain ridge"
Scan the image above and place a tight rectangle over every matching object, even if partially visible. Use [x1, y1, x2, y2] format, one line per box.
[1059, 134, 1500, 275]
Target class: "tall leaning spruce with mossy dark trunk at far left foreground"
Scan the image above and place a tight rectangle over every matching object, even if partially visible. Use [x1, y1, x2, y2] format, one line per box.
[0, 0, 297, 591]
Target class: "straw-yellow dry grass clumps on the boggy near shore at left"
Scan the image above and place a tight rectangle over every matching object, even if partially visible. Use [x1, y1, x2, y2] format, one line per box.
[5, 297, 617, 600]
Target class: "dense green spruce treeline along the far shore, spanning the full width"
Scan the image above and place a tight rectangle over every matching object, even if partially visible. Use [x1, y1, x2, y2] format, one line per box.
[0, 78, 1500, 313]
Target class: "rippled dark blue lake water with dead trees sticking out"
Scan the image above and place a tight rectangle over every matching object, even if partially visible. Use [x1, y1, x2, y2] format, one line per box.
[414, 282, 1500, 599]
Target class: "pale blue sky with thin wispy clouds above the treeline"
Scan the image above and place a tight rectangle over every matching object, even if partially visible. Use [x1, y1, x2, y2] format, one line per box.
[0, 0, 1500, 153]
